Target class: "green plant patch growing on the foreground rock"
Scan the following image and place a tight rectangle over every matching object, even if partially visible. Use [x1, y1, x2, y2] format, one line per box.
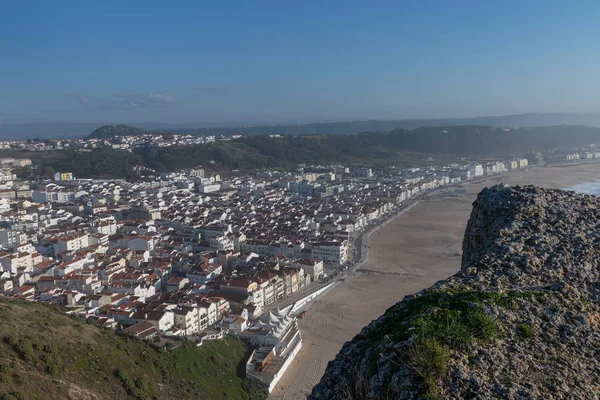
[363, 290, 546, 398]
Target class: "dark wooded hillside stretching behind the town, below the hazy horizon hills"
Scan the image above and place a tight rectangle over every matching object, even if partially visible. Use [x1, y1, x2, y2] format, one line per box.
[15, 126, 600, 178]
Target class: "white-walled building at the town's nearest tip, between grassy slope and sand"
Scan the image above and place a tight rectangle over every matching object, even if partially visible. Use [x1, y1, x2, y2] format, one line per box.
[240, 306, 302, 392]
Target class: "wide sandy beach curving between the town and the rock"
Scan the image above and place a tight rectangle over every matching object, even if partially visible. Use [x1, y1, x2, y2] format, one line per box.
[270, 163, 600, 399]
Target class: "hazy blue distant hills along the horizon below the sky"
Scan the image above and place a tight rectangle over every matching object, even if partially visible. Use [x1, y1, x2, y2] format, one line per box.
[0, 113, 600, 140]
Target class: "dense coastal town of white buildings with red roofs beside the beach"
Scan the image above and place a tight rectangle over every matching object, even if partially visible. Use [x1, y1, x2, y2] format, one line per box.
[0, 151, 600, 391]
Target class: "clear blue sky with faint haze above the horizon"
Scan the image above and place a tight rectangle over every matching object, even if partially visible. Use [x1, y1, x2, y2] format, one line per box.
[0, 0, 600, 123]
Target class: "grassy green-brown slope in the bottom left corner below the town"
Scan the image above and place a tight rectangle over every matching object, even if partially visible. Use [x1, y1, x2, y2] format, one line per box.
[0, 297, 266, 400]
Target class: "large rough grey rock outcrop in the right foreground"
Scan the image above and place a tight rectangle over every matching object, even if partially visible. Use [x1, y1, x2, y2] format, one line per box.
[309, 185, 600, 399]
